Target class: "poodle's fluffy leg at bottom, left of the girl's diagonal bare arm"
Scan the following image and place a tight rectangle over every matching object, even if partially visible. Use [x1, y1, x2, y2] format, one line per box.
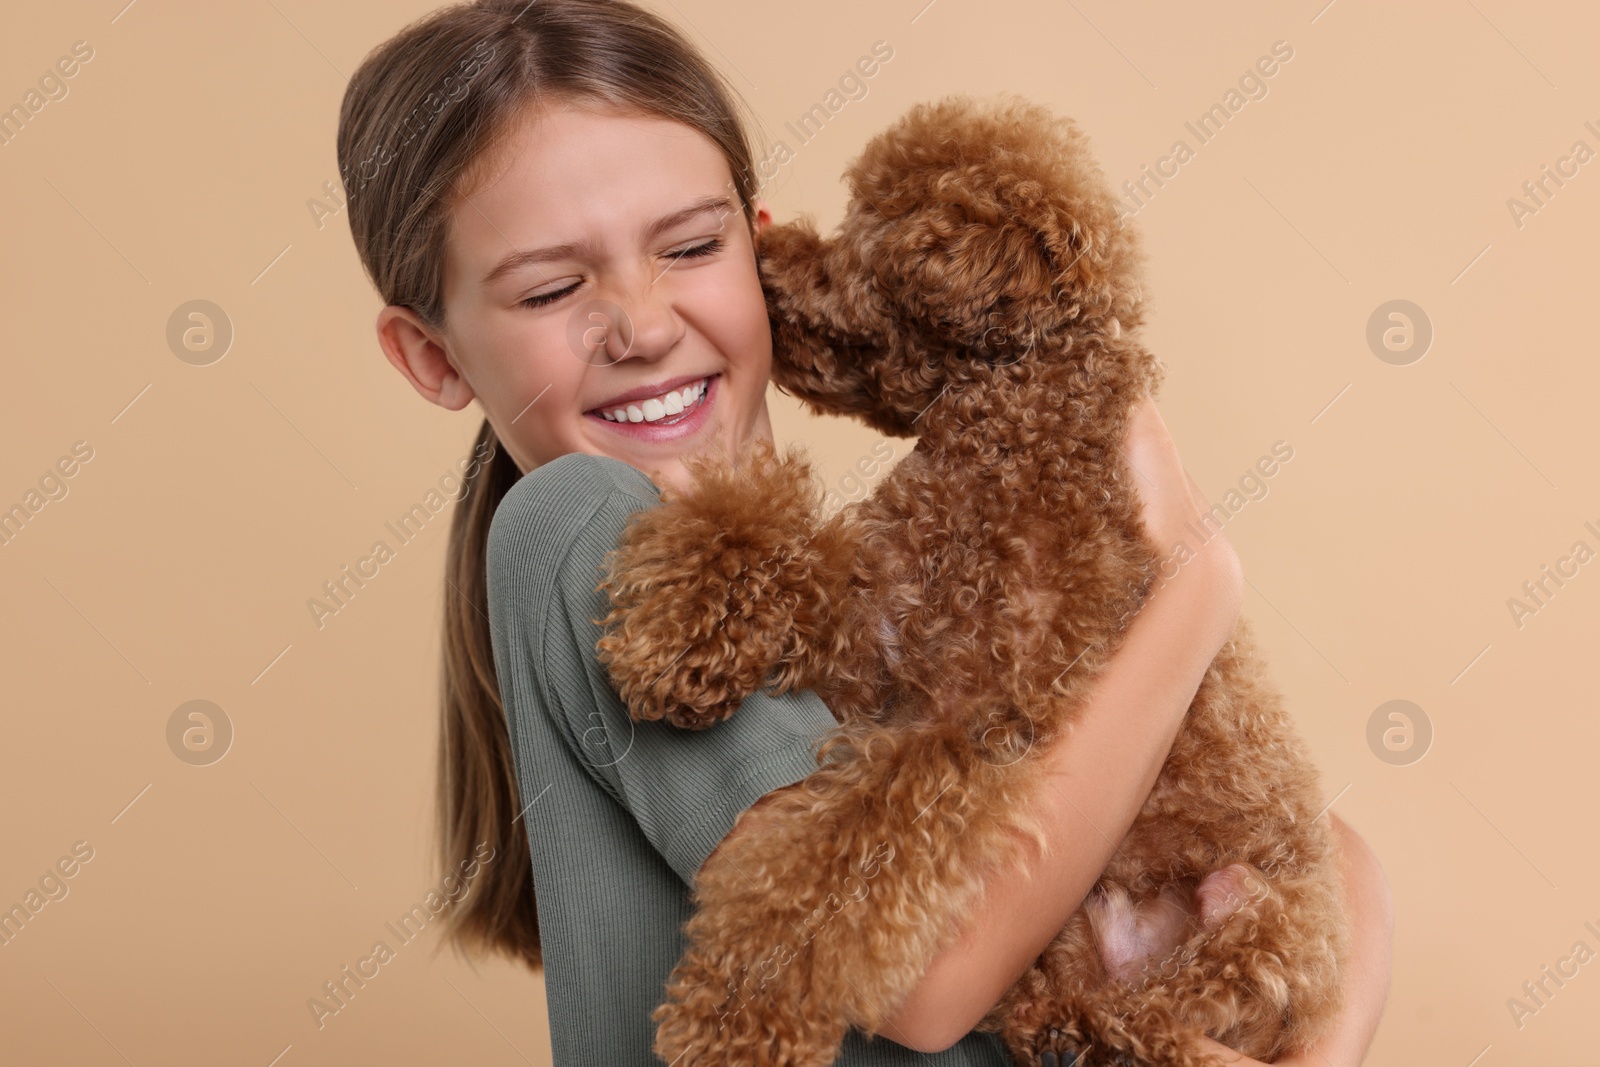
[653, 723, 1037, 1067]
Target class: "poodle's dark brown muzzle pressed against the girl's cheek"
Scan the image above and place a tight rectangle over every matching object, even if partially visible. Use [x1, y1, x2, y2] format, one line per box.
[755, 218, 910, 437]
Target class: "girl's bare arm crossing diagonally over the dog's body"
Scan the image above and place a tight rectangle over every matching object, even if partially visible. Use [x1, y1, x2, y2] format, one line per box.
[882, 552, 1243, 1051]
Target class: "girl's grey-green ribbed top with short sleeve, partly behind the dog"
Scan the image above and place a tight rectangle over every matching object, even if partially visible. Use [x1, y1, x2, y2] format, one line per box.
[488, 453, 1010, 1067]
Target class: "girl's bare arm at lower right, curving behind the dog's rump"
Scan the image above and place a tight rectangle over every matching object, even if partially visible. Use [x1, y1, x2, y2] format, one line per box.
[1202, 811, 1395, 1067]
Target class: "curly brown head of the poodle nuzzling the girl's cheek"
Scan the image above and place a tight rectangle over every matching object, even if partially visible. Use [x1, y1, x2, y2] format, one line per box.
[757, 94, 1142, 437]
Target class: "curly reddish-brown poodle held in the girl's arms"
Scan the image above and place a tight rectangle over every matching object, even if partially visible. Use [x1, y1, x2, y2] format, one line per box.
[600, 96, 1347, 1067]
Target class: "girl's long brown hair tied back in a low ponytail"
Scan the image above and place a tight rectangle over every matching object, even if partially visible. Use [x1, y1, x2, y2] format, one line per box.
[338, 0, 757, 968]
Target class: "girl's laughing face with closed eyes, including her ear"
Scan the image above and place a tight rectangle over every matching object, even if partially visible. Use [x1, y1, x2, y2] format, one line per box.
[378, 102, 773, 488]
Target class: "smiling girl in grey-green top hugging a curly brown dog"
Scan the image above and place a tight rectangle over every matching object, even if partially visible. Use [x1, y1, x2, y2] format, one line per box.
[338, 0, 1389, 1067]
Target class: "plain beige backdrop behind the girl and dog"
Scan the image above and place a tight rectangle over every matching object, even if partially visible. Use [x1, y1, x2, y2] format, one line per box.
[0, 0, 1600, 1067]
